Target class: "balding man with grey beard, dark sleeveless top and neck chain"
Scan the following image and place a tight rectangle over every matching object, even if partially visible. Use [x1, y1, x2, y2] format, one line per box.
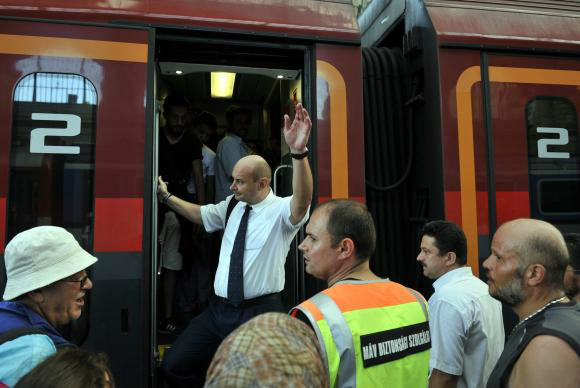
[483, 219, 580, 388]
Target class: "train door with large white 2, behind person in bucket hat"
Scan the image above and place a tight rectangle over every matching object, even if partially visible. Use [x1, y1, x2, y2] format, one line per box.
[0, 20, 149, 387]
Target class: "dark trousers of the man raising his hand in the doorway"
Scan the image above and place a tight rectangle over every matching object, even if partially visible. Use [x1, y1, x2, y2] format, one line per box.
[163, 294, 285, 388]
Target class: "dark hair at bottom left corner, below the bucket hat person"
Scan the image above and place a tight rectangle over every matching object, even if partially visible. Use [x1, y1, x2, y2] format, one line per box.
[14, 348, 115, 388]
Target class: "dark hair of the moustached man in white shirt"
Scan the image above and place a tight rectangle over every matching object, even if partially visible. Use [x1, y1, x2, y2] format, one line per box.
[420, 221, 467, 265]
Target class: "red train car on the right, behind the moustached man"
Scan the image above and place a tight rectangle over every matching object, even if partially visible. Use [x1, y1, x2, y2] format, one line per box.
[359, 0, 580, 294]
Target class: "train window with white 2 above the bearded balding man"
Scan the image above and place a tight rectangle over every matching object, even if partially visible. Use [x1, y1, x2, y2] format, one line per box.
[526, 97, 580, 217]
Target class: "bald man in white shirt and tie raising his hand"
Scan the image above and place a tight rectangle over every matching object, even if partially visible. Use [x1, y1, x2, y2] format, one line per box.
[157, 104, 313, 387]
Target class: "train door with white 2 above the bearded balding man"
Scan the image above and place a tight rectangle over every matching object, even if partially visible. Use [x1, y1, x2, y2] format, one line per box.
[484, 54, 580, 232]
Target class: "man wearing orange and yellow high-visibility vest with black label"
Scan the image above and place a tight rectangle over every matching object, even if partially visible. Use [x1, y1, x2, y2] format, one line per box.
[291, 200, 430, 388]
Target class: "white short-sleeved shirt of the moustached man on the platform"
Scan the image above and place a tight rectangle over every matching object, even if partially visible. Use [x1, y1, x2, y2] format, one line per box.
[429, 267, 505, 388]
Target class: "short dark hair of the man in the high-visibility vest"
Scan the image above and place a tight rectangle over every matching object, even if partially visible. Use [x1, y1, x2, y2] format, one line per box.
[316, 199, 377, 260]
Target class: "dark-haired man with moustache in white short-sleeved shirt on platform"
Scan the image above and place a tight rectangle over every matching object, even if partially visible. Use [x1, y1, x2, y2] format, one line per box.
[417, 221, 505, 388]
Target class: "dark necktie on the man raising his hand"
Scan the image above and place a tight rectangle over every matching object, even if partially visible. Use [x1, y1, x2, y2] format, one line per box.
[228, 205, 252, 306]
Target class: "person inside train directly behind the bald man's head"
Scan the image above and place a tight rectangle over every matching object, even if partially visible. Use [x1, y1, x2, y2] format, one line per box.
[215, 105, 252, 202]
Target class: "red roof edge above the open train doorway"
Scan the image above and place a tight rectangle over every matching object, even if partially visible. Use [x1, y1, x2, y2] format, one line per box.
[0, 0, 360, 41]
